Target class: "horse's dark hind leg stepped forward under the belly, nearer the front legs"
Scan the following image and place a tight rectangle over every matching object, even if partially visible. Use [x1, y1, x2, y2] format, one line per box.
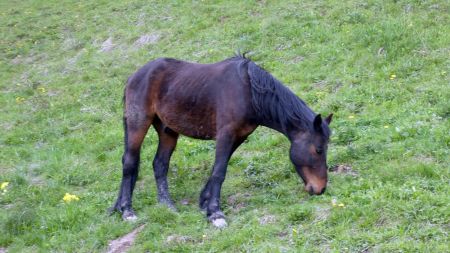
[153, 118, 178, 211]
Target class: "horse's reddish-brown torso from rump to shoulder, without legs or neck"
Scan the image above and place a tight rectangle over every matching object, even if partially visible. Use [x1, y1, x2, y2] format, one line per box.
[128, 58, 251, 139]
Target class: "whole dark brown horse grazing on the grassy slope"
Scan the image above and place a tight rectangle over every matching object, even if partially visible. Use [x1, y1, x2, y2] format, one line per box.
[112, 56, 332, 227]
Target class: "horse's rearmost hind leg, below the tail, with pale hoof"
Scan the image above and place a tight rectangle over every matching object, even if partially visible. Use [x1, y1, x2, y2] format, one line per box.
[110, 112, 152, 220]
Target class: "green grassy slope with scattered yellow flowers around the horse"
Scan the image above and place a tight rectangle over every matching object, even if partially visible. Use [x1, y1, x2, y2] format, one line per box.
[0, 0, 450, 252]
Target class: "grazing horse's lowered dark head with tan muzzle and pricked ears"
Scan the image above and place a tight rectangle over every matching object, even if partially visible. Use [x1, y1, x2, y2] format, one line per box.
[290, 114, 333, 195]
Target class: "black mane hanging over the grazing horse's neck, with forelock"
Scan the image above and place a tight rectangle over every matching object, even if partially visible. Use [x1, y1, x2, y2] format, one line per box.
[246, 59, 320, 137]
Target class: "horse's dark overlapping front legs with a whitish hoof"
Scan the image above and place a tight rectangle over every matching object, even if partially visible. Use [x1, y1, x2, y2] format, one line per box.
[200, 134, 245, 228]
